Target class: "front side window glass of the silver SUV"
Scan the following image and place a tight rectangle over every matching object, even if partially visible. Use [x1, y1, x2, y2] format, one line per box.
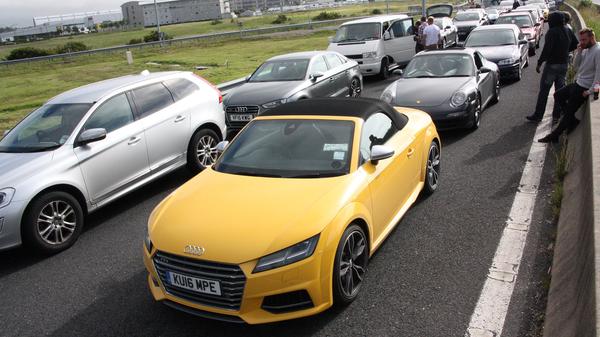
[83, 94, 133, 132]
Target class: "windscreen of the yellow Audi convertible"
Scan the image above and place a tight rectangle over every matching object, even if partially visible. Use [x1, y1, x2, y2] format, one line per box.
[214, 119, 354, 178]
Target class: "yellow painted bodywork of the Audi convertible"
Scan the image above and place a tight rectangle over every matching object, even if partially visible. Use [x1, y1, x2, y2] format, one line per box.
[144, 108, 439, 324]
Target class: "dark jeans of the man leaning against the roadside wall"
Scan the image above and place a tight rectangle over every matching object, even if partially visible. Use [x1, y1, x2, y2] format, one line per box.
[551, 83, 589, 137]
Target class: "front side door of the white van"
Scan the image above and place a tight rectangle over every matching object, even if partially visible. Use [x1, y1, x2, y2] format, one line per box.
[384, 18, 415, 64]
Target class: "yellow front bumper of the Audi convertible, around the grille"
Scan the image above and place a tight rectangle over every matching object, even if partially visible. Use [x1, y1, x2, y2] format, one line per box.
[143, 247, 333, 324]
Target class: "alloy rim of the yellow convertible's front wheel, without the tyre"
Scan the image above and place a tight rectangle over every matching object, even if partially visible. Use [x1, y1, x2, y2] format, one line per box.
[340, 231, 368, 297]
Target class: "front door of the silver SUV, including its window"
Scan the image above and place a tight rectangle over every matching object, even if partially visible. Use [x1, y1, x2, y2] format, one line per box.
[74, 93, 150, 203]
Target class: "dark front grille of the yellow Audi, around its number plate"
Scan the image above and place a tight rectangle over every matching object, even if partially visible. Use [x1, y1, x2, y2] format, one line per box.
[153, 251, 246, 310]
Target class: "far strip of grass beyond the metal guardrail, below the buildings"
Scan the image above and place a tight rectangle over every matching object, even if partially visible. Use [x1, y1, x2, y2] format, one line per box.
[0, 0, 432, 58]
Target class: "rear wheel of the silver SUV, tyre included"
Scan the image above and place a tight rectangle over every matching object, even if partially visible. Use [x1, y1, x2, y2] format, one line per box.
[187, 129, 220, 173]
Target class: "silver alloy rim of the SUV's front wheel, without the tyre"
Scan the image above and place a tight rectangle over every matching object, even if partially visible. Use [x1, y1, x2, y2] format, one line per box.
[37, 200, 77, 245]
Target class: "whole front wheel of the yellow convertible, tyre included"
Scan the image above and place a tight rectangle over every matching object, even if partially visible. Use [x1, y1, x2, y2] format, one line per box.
[333, 224, 369, 306]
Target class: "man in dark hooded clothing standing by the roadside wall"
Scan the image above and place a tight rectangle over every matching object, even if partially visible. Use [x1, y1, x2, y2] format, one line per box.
[527, 12, 578, 122]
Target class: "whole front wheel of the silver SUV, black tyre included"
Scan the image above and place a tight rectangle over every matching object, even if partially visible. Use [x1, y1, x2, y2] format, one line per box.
[21, 191, 84, 254]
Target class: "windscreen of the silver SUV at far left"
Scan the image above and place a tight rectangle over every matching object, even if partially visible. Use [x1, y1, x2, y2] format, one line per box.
[0, 104, 92, 152]
